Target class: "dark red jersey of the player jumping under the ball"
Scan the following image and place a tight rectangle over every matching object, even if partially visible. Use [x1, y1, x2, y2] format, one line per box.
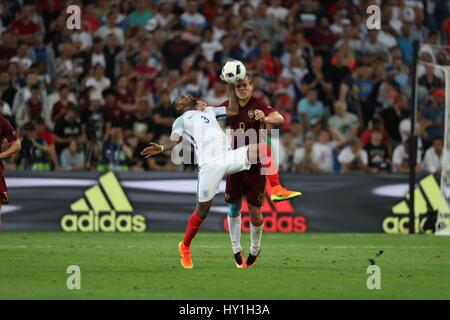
[221, 96, 275, 149]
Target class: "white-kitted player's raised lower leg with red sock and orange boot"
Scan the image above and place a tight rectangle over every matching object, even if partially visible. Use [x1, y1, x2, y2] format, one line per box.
[259, 142, 302, 202]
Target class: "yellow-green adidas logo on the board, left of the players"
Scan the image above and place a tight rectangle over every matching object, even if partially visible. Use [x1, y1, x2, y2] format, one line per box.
[61, 172, 146, 232]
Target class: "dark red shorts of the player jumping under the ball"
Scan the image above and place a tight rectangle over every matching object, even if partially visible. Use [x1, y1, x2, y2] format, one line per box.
[225, 164, 266, 207]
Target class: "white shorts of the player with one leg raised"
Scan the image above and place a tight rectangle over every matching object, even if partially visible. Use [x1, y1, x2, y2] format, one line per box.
[197, 146, 252, 202]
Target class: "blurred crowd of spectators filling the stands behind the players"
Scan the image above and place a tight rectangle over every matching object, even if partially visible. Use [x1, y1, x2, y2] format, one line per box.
[0, 0, 450, 173]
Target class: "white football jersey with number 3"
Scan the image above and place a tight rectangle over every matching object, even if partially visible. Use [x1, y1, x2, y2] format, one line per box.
[171, 107, 231, 166]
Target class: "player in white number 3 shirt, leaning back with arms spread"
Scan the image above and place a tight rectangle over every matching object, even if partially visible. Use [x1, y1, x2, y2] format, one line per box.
[141, 95, 258, 269]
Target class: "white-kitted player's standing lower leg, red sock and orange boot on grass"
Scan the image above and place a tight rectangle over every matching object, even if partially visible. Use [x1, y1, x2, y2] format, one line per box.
[178, 200, 212, 269]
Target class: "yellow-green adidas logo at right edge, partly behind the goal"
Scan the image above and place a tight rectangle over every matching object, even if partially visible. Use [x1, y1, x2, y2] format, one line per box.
[383, 175, 450, 234]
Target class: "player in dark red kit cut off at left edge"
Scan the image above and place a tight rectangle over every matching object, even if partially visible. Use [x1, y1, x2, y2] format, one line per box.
[0, 115, 20, 226]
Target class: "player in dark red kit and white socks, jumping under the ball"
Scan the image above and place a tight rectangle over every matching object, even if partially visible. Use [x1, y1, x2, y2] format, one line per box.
[222, 73, 301, 268]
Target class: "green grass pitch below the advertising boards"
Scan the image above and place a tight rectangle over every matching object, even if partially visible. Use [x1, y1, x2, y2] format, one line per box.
[0, 232, 450, 300]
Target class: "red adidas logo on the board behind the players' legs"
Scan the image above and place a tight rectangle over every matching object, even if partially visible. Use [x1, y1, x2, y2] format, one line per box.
[223, 185, 308, 233]
